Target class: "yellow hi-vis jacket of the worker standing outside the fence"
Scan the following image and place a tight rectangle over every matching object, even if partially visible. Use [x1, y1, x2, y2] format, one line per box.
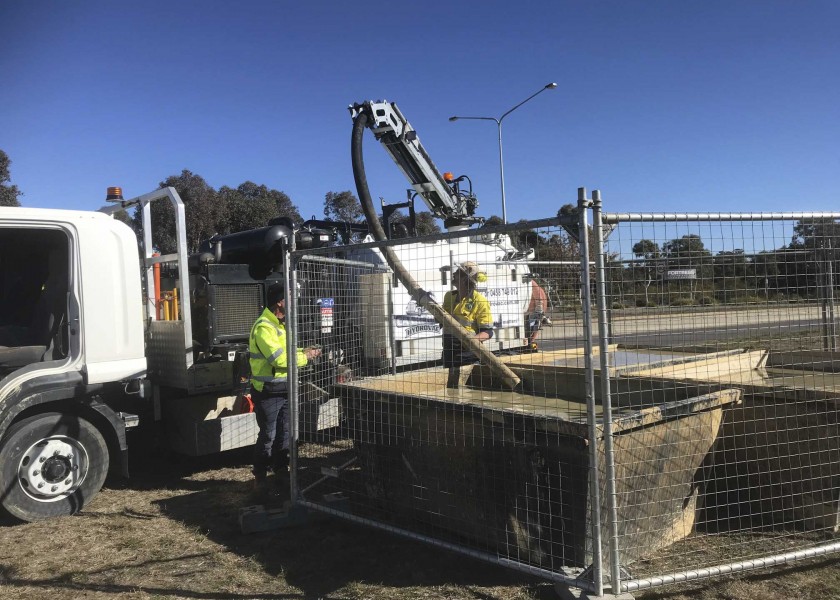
[248, 308, 307, 392]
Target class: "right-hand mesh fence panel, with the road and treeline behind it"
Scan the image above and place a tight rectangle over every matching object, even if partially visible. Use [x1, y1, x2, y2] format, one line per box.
[581, 192, 840, 591]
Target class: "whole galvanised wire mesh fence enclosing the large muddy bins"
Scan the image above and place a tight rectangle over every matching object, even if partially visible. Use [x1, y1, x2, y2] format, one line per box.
[282, 196, 840, 593]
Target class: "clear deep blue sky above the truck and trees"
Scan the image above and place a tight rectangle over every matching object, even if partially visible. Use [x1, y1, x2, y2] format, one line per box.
[0, 0, 840, 220]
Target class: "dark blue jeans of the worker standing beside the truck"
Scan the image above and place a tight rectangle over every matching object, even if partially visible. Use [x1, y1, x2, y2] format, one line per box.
[251, 386, 289, 479]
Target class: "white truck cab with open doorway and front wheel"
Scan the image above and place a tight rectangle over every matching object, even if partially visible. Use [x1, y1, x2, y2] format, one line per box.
[0, 208, 146, 520]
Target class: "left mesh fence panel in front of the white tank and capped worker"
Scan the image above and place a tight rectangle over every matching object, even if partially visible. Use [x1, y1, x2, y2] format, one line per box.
[292, 218, 603, 592]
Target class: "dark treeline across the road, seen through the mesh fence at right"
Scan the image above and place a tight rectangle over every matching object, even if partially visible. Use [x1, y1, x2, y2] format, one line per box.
[498, 205, 840, 308]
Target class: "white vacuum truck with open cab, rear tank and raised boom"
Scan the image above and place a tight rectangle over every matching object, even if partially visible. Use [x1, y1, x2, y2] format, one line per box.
[0, 98, 531, 521]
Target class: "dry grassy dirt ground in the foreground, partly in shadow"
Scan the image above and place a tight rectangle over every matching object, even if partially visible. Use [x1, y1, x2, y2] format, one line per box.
[0, 452, 840, 600]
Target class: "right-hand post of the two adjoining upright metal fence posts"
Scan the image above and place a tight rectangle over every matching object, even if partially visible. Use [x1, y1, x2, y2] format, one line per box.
[592, 190, 621, 594]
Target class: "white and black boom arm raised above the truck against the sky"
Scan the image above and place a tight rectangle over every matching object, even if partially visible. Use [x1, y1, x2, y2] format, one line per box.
[350, 100, 483, 227]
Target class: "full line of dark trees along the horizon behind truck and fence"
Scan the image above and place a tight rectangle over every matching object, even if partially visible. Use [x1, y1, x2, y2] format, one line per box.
[9, 150, 840, 307]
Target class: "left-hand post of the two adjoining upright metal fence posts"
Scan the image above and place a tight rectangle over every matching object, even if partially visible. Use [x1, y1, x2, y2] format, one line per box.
[577, 188, 604, 596]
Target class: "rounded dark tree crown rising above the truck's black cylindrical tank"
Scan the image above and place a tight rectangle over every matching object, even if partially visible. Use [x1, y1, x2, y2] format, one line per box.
[217, 181, 303, 234]
